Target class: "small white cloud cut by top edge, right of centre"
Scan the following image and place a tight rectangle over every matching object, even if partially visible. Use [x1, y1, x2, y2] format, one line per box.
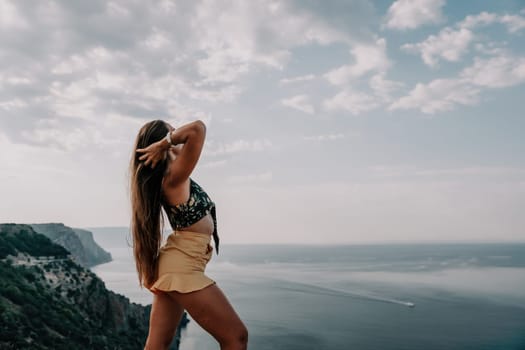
[386, 0, 445, 29]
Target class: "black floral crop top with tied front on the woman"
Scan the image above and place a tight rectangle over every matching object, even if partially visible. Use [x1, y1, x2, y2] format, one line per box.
[162, 177, 219, 254]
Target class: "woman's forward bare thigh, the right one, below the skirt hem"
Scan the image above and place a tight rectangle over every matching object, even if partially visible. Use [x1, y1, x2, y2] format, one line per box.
[169, 283, 247, 342]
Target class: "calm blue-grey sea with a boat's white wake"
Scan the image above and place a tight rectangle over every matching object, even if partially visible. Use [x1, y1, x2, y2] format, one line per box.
[89, 228, 525, 350]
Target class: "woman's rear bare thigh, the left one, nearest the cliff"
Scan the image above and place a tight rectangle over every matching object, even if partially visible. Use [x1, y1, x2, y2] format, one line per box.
[146, 292, 184, 349]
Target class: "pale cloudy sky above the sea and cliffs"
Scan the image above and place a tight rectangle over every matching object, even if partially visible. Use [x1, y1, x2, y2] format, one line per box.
[0, 0, 525, 244]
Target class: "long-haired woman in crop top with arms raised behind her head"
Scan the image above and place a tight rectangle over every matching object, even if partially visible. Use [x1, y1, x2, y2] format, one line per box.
[130, 120, 248, 350]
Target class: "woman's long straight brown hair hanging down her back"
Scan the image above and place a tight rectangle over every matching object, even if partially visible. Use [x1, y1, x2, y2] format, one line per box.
[129, 120, 169, 288]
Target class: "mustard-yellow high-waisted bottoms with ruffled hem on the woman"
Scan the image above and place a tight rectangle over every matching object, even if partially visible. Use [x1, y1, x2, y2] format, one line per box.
[150, 230, 215, 293]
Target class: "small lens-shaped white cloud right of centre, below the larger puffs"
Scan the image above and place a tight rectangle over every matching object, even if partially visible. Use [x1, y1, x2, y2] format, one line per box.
[323, 88, 381, 115]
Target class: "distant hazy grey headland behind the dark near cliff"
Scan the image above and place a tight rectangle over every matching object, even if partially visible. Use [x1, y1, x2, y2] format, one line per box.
[31, 223, 111, 267]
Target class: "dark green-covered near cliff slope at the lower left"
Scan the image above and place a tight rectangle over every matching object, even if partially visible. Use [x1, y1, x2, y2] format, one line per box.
[0, 224, 187, 349]
